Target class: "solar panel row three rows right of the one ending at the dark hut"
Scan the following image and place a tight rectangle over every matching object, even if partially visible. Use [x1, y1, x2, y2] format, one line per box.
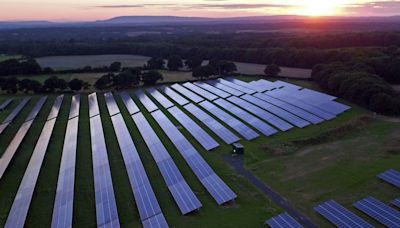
[228, 97, 293, 131]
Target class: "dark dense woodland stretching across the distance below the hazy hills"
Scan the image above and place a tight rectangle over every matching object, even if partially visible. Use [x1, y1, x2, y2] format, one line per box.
[0, 28, 400, 114]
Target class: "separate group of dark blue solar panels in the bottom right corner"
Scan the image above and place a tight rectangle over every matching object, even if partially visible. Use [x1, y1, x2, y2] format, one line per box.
[266, 169, 400, 228]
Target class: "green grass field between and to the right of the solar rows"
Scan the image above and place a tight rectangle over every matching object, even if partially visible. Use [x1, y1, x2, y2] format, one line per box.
[0, 77, 400, 227]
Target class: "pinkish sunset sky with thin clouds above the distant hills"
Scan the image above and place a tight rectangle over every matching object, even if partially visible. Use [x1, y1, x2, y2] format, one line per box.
[0, 0, 400, 21]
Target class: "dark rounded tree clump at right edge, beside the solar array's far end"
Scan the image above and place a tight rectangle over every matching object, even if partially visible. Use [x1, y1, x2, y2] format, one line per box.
[312, 62, 400, 115]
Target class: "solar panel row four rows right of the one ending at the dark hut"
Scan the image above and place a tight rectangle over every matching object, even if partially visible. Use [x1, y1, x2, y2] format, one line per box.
[240, 94, 310, 128]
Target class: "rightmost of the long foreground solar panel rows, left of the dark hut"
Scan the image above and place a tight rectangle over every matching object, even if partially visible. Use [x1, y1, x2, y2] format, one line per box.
[151, 110, 237, 205]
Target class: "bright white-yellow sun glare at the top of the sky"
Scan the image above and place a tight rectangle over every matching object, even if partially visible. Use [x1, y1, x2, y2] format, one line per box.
[297, 0, 346, 17]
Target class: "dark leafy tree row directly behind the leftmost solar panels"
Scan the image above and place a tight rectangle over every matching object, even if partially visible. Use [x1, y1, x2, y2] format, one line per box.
[0, 76, 90, 94]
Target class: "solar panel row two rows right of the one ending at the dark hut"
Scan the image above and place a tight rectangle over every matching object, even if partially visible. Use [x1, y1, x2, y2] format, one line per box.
[214, 98, 278, 136]
